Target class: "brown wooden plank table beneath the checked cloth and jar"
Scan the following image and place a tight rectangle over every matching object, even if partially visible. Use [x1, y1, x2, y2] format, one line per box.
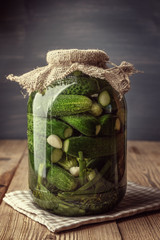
[0, 140, 160, 240]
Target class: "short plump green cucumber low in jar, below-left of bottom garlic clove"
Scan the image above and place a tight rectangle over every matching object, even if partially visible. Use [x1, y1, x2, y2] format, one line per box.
[47, 164, 78, 191]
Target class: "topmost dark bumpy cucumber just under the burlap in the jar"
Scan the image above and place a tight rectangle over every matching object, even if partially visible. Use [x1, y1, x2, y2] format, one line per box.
[51, 74, 99, 96]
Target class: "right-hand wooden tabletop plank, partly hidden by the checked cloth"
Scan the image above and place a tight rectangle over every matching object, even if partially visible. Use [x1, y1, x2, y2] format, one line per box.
[117, 141, 160, 240]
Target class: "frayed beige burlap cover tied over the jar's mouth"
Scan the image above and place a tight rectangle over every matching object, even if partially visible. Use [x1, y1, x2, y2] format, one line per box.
[7, 49, 137, 98]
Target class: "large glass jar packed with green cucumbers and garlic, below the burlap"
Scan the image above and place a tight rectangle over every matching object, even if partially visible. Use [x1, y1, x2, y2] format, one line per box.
[27, 71, 126, 216]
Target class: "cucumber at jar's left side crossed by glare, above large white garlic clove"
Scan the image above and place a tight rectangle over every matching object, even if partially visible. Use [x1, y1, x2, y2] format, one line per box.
[27, 114, 73, 139]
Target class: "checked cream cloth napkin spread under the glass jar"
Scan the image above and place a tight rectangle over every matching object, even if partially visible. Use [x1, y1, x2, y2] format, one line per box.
[3, 182, 160, 232]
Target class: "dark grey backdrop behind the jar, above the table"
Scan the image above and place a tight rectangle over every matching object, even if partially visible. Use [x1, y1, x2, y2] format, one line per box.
[0, 0, 160, 140]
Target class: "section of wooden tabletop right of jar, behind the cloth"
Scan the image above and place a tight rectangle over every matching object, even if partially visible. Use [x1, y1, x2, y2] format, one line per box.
[128, 141, 160, 188]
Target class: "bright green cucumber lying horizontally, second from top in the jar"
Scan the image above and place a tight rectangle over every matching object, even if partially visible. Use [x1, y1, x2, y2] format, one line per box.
[48, 95, 92, 117]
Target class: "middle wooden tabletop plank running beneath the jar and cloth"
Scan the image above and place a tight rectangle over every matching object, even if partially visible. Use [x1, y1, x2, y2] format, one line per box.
[0, 144, 122, 240]
